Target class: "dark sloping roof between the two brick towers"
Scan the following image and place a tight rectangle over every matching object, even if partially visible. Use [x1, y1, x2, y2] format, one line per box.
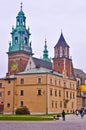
[33, 57, 52, 69]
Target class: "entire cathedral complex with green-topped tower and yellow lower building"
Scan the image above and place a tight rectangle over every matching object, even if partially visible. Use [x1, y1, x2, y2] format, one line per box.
[0, 4, 85, 114]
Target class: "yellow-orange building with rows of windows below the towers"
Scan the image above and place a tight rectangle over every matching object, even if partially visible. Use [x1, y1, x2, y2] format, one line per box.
[0, 68, 76, 114]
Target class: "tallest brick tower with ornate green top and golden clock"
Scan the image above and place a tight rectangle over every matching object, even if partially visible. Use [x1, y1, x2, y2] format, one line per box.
[7, 3, 33, 75]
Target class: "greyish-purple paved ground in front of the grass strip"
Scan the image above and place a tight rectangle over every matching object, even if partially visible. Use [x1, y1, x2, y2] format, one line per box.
[0, 115, 86, 130]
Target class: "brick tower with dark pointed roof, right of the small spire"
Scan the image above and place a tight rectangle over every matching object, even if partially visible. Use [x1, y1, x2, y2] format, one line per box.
[53, 33, 75, 78]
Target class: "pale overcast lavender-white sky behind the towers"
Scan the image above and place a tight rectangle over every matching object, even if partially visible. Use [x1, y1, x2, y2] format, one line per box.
[0, 0, 86, 77]
